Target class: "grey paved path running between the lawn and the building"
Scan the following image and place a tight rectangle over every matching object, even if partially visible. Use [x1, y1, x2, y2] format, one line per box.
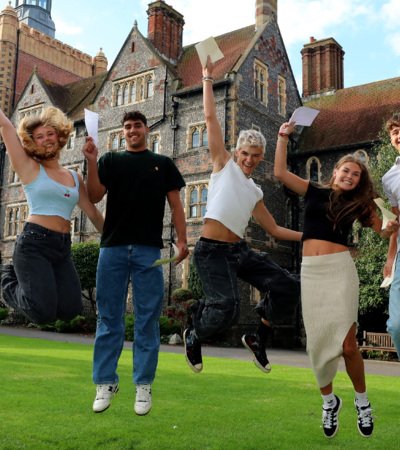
[0, 325, 400, 376]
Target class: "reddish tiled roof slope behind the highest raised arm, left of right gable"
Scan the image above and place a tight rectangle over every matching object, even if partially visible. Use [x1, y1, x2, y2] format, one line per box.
[177, 24, 257, 88]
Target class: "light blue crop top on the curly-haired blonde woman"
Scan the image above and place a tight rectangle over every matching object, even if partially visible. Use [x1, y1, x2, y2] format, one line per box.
[24, 164, 79, 220]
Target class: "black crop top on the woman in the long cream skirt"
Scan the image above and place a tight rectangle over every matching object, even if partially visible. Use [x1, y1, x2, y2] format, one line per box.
[302, 182, 353, 246]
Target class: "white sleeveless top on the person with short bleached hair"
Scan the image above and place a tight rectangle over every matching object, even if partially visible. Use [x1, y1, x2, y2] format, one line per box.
[204, 159, 264, 238]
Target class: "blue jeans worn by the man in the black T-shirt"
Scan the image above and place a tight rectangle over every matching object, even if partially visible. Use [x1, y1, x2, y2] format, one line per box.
[93, 245, 164, 384]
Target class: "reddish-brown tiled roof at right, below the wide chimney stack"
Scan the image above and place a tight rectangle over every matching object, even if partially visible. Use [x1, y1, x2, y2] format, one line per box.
[299, 78, 400, 152]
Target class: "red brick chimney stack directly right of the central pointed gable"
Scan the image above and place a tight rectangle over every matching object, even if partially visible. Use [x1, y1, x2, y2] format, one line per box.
[147, 0, 185, 63]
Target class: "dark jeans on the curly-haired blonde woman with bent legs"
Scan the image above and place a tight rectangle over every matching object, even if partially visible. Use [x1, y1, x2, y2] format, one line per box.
[1, 222, 82, 324]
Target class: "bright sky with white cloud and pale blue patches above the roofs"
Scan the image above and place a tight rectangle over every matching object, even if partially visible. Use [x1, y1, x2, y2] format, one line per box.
[41, 0, 400, 94]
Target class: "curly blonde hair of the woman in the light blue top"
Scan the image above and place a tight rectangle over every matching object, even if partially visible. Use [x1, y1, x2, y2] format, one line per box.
[17, 106, 74, 156]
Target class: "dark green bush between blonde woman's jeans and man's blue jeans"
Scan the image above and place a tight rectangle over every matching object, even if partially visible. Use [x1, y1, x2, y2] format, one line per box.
[71, 241, 100, 312]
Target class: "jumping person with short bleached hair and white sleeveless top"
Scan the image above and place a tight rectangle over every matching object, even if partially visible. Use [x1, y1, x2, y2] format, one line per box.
[184, 61, 301, 373]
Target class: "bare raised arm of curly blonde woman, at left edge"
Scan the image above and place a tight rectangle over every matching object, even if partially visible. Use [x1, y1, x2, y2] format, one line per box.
[0, 109, 37, 183]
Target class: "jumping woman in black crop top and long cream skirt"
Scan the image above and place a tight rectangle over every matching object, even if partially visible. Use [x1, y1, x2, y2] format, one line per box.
[274, 123, 398, 438]
